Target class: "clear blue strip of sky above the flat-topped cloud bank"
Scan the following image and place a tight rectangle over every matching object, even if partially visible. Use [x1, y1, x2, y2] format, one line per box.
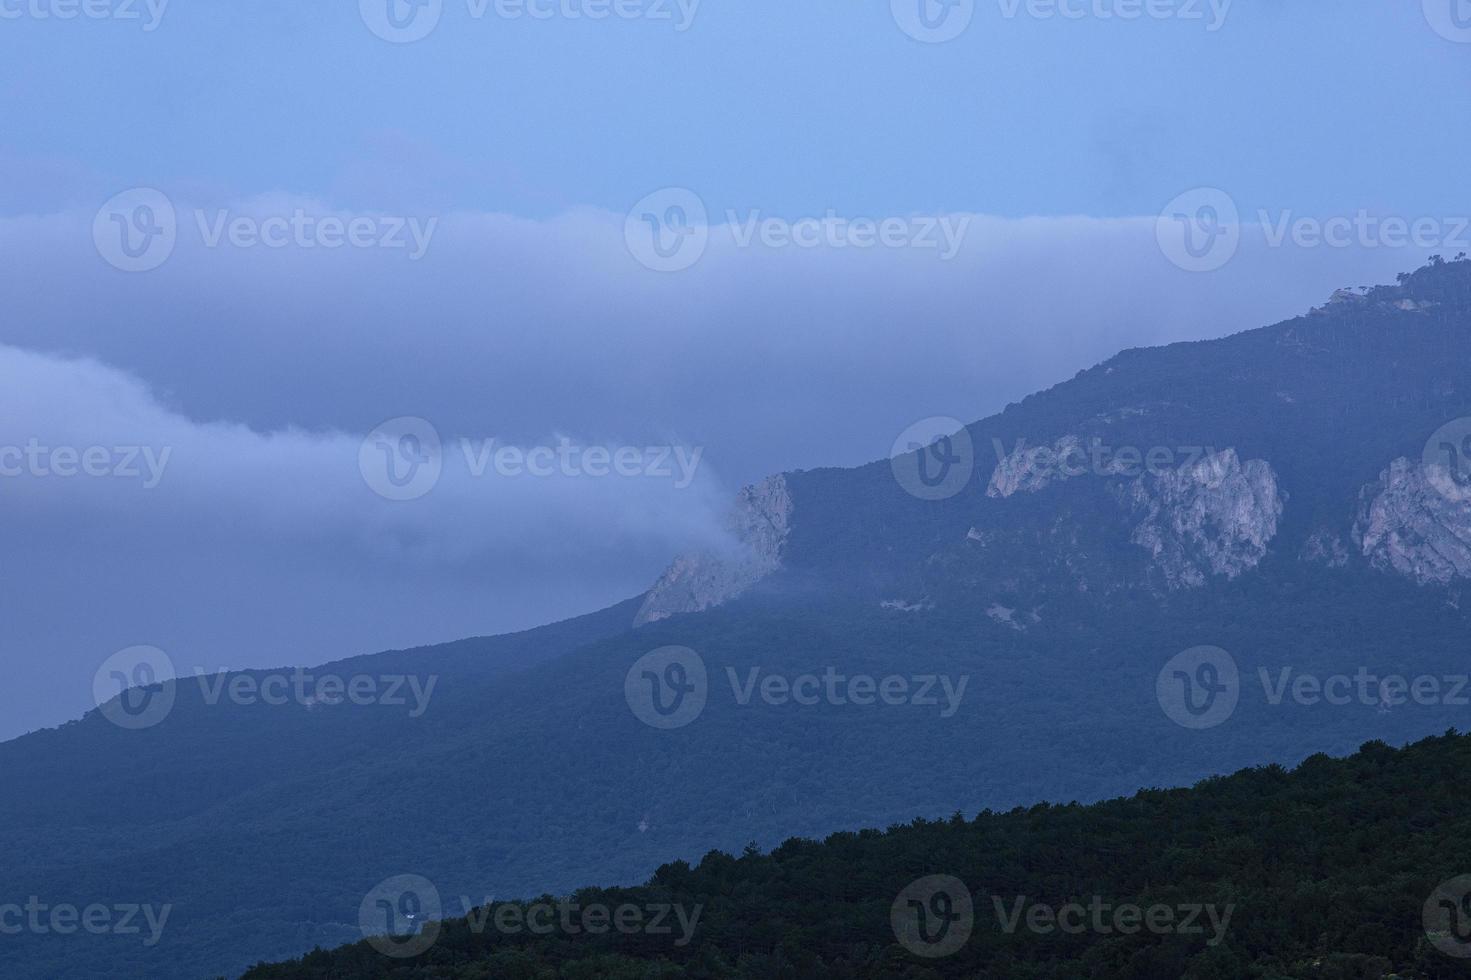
[0, 0, 1471, 216]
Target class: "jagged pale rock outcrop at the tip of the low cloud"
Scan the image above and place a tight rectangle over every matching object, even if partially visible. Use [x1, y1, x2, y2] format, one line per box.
[634, 475, 791, 625]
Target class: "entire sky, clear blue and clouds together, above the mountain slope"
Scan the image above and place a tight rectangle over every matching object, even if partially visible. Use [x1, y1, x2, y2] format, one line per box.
[0, 0, 1471, 737]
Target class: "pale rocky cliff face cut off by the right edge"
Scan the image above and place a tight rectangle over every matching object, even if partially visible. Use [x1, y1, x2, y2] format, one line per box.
[1353, 458, 1471, 586]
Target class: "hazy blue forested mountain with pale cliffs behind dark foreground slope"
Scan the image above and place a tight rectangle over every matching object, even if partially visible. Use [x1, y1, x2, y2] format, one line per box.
[11, 259, 1471, 980]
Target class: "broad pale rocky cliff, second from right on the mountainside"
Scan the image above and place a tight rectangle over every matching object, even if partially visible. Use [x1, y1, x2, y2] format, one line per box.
[1125, 449, 1286, 589]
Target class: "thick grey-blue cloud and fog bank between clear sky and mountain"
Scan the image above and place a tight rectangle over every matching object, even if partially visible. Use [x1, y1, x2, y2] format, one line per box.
[0, 211, 1435, 736]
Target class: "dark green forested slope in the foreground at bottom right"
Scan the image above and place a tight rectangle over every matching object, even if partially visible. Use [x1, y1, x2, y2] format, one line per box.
[246, 731, 1471, 980]
